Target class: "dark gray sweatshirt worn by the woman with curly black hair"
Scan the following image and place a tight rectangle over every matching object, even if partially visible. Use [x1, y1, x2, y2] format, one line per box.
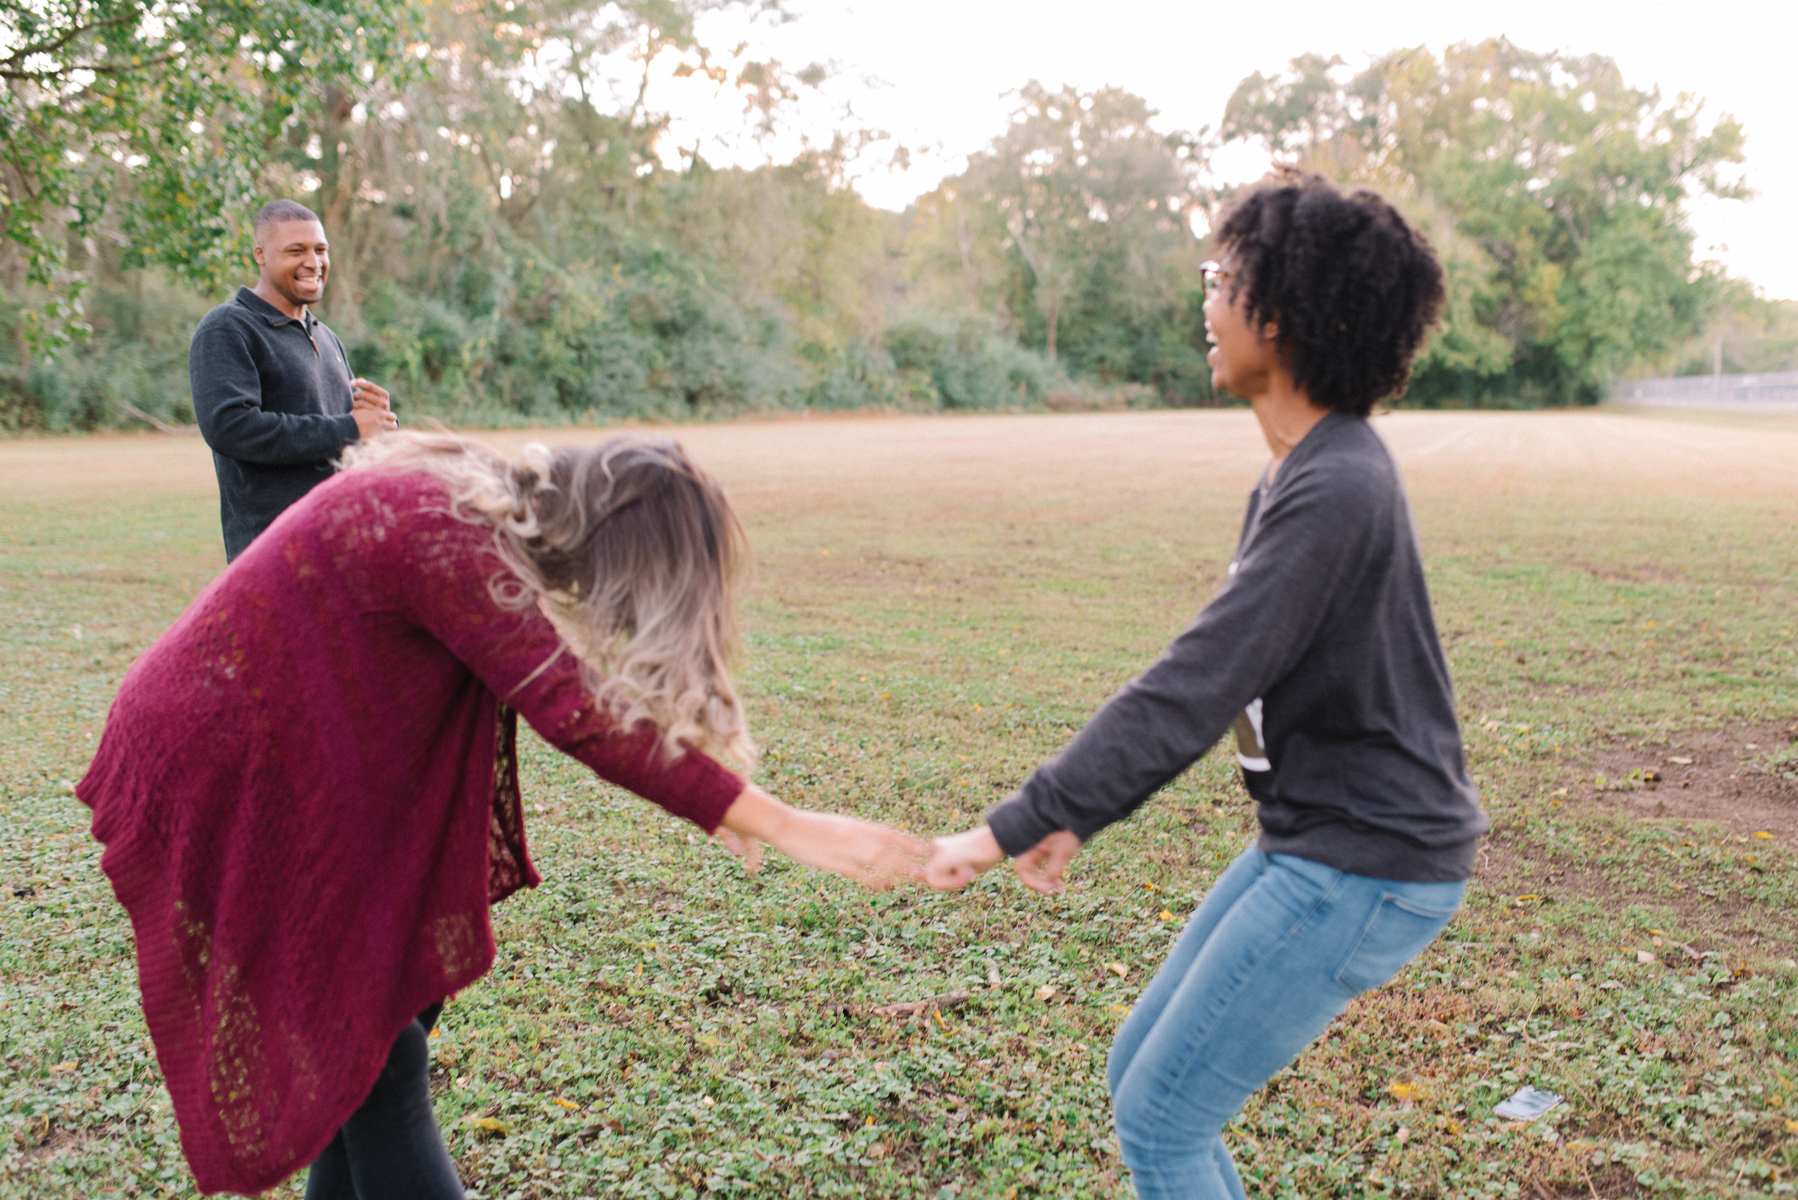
[987, 414, 1489, 882]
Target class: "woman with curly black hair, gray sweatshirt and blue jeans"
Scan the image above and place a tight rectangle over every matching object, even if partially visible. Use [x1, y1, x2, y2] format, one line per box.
[924, 173, 1487, 1200]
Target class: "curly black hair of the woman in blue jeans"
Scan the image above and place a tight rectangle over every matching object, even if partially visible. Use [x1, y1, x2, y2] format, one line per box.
[1217, 167, 1442, 416]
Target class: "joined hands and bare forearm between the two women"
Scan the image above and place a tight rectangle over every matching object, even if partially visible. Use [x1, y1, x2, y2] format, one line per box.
[716, 784, 1081, 896]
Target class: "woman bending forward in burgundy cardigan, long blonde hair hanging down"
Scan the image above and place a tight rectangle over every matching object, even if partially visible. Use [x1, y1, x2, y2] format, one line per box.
[77, 434, 917, 1200]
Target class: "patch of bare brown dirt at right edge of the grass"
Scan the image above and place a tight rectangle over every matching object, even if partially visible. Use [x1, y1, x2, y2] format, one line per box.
[1568, 720, 1798, 849]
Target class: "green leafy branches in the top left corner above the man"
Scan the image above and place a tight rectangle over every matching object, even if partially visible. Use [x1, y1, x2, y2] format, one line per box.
[0, 0, 415, 349]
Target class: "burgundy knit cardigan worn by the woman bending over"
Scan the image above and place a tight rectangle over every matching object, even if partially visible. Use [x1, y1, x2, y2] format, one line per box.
[77, 470, 743, 1193]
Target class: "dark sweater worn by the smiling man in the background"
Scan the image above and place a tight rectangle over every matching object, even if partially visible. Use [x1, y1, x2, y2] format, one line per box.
[187, 288, 358, 561]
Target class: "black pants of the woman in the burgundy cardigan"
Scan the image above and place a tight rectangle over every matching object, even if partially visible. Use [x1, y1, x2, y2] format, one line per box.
[306, 1004, 462, 1200]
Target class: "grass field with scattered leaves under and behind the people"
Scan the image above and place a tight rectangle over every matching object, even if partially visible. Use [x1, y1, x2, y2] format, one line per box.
[0, 412, 1798, 1200]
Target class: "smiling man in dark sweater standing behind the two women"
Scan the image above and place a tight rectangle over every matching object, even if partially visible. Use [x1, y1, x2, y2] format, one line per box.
[187, 200, 397, 561]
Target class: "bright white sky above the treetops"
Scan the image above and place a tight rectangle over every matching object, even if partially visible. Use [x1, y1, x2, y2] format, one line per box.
[656, 0, 1798, 299]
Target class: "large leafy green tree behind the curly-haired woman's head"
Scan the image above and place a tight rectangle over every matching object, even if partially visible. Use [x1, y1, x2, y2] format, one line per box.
[1223, 40, 1746, 403]
